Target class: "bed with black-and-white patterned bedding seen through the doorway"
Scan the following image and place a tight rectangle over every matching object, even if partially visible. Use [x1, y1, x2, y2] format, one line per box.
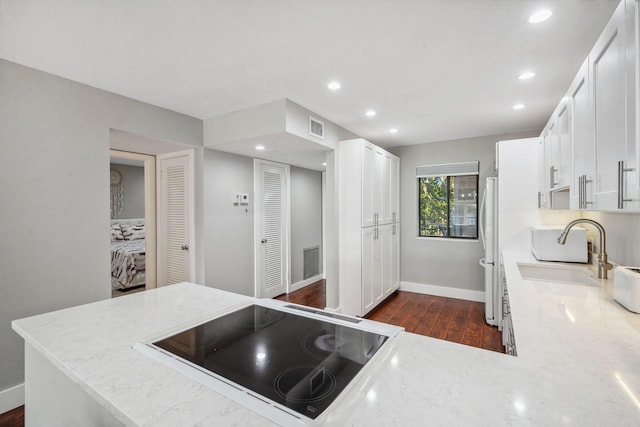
[111, 218, 146, 290]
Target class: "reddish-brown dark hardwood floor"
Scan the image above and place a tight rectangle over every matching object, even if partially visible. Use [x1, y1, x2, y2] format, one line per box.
[0, 280, 504, 427]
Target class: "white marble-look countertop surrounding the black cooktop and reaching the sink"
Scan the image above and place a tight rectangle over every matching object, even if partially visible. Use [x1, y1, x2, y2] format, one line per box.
[13, 253, 640, 426]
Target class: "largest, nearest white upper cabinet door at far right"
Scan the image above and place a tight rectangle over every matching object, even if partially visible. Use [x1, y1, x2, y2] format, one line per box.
[589, 1, 638, 210]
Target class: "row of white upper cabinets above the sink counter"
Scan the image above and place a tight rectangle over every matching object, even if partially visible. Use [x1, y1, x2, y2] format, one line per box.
[540, 0, 640, 211]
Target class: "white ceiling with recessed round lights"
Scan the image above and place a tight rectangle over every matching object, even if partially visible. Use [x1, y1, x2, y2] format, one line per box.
[0, 0, 618, 154]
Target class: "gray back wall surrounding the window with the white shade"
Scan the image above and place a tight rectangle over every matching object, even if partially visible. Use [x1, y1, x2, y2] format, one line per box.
[389, 133, 536, 291]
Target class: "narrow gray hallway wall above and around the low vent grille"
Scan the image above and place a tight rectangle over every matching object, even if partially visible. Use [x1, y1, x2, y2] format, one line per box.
[290, 166, 322, 284]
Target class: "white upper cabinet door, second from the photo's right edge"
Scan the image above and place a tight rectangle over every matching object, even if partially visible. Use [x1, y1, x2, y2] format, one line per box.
[567, 61, 596, 209]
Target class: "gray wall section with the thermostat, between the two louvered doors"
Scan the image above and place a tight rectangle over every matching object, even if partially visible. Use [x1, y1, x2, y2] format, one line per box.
[203, 148, 255, 296]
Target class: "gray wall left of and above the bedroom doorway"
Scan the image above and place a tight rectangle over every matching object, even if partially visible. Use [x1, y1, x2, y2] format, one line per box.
[0, 60, 202, 409]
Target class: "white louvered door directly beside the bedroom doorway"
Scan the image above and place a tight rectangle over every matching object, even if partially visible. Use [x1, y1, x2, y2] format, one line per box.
[157, 150, 195, 286]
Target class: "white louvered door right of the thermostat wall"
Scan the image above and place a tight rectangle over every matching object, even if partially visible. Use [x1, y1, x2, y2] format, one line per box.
[254, 159, 289, 298]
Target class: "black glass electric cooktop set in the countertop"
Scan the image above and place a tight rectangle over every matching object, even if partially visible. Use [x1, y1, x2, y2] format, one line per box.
[153, 305, 387, 419]
